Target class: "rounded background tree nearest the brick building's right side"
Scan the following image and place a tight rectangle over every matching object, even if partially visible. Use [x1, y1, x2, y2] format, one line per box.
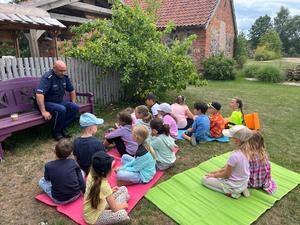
[249, 15, 272, 49]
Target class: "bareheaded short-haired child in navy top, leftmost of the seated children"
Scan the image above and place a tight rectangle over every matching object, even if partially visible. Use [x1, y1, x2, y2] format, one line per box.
[39, 139, 85, 204]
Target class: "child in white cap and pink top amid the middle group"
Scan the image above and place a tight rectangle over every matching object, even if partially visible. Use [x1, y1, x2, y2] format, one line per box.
[157, 103, 178, 139]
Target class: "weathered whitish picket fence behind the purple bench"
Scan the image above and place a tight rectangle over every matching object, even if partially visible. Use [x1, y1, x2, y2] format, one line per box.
[0, 57, 122, 104]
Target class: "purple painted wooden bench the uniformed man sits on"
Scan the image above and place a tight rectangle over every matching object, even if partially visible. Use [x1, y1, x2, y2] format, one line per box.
[0, 77, 94, 161]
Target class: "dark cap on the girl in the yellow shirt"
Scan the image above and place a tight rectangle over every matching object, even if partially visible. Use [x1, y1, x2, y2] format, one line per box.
[92, 151, 114, 176]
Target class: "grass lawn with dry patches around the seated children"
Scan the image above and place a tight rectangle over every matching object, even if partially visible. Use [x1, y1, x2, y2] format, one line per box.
[0, 78, 300, 225]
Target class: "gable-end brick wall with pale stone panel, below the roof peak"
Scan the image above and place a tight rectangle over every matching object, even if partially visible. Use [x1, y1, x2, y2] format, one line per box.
[205, 0, 235, 57]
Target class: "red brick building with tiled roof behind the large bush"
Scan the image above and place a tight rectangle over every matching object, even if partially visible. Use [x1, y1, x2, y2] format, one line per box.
[125, 0, 237, 68]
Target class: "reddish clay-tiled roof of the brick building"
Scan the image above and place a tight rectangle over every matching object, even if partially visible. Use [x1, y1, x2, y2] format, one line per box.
[125, 0, 218, 27]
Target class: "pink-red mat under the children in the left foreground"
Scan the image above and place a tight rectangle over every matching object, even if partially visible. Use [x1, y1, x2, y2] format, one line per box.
[35, 149, 179, 225]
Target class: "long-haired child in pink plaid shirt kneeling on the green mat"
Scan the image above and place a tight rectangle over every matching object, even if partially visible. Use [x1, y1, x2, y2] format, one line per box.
[248, 131, 277, 194]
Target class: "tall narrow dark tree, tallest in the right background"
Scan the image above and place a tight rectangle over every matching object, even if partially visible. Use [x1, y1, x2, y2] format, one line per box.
[274, 7, 291, 53]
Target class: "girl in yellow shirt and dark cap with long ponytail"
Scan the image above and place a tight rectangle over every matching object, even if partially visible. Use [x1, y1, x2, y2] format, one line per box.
[83, 152, 129, 224]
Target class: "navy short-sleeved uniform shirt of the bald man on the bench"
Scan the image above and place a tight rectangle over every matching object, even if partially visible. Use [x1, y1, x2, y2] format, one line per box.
[36, 69, 74, 103]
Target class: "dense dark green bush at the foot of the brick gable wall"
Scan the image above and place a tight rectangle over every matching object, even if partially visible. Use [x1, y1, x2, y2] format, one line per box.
[202, 55, 235, 80]
